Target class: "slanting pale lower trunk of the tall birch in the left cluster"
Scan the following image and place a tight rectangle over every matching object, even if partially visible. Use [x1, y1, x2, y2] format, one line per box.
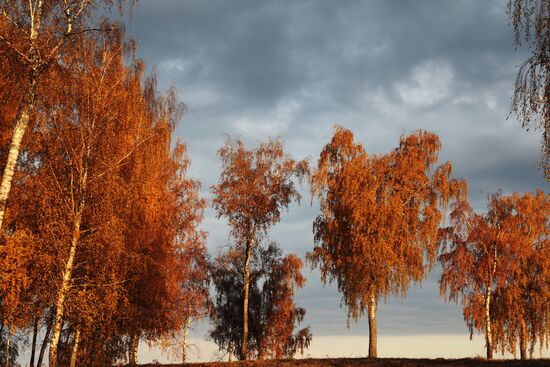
[49, 213, 83, 367]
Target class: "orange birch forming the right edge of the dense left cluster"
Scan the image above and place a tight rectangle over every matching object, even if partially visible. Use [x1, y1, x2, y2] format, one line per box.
[121, 139, 209, 364]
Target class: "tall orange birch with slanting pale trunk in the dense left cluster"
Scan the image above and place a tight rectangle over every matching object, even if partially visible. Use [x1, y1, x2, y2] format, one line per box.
[25, 31, 163, 366]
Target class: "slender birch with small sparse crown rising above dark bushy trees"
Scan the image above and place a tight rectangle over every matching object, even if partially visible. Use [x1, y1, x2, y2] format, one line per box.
[212, 138, 308, 360]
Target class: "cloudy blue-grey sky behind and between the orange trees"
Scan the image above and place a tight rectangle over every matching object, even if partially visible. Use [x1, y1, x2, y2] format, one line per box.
[119, 0, 550, 362]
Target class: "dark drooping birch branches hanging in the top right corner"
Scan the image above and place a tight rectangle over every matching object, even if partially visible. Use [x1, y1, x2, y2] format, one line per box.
[508, 0, 550, 180]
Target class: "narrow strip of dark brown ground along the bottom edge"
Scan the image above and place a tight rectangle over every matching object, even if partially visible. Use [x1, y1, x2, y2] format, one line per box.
[142, 358, 550, 367]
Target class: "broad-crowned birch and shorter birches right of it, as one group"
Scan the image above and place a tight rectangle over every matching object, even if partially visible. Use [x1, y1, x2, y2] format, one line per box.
[308, 128, 550, 358]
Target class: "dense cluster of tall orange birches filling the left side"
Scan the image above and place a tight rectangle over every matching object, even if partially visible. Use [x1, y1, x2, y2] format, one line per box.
[0, 7, 209, 366]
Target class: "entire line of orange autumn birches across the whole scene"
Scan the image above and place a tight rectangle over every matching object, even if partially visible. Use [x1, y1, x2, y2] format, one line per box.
[0, 0, 550, 367]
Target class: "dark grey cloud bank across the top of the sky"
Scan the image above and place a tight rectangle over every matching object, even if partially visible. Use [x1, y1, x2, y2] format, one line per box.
[130, 1, 511, 114]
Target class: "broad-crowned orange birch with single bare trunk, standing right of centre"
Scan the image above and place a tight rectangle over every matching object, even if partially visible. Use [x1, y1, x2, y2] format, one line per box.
[307, 127, 466, 358]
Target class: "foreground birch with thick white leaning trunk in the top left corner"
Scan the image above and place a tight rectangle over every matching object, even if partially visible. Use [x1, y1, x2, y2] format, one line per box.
[0, 0, 133, 230]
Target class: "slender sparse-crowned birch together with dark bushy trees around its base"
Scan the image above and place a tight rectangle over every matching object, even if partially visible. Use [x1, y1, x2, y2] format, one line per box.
[211, 138, 311, 360]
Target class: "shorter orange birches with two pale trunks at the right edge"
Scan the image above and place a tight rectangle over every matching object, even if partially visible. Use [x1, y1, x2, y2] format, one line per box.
[439, 191, 550, 359]
